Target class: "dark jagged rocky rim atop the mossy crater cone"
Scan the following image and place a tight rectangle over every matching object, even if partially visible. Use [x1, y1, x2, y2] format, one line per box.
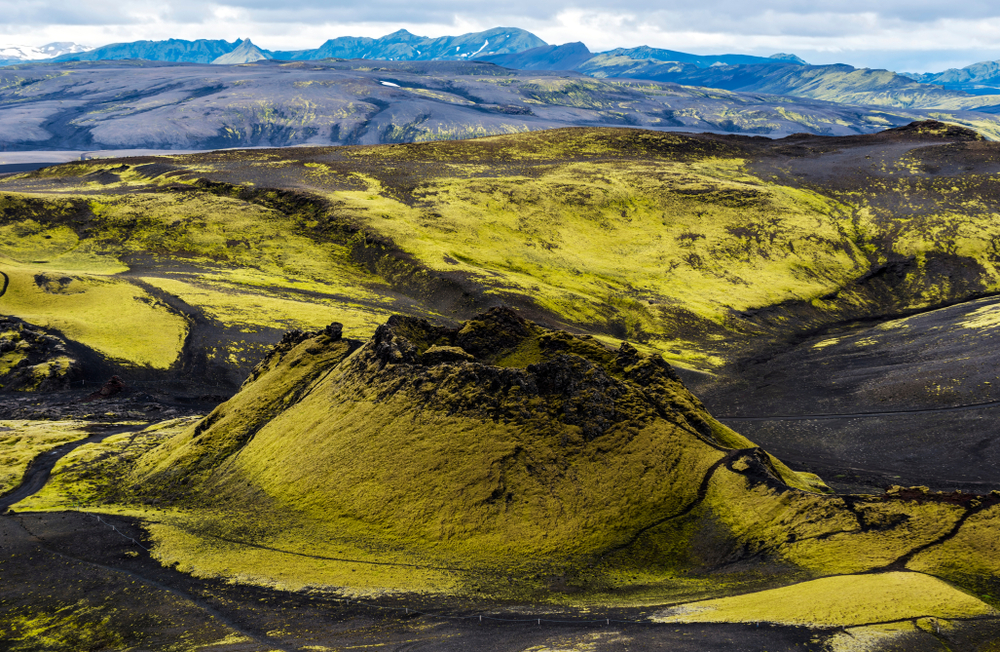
[352, 308, 717, 443]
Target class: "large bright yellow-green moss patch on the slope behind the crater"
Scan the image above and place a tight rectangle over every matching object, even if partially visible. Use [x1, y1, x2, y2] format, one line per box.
[318, 152, 867, 367]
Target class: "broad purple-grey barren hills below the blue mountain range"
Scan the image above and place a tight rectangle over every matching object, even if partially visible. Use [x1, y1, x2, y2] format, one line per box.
[0, 58, 1000, 151]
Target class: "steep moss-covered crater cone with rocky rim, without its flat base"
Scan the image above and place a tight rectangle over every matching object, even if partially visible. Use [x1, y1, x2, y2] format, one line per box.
[129, 311, 828, 590]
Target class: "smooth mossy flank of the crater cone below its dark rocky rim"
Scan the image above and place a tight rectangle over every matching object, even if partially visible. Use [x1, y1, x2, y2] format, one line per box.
[136, 314, 736, 563]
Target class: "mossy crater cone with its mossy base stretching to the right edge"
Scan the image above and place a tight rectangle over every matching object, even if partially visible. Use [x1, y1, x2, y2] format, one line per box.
[32, 309, 968, 608]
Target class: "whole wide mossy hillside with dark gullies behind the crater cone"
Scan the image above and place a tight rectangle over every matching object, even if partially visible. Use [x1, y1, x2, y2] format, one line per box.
[0, 123, 1000, 383]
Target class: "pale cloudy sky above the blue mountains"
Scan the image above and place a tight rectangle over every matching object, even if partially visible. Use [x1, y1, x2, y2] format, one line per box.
[0, 0, 1000, 72]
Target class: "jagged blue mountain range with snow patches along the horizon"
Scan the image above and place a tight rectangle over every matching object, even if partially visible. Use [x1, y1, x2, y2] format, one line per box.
[0, 27, 1000, 119]
